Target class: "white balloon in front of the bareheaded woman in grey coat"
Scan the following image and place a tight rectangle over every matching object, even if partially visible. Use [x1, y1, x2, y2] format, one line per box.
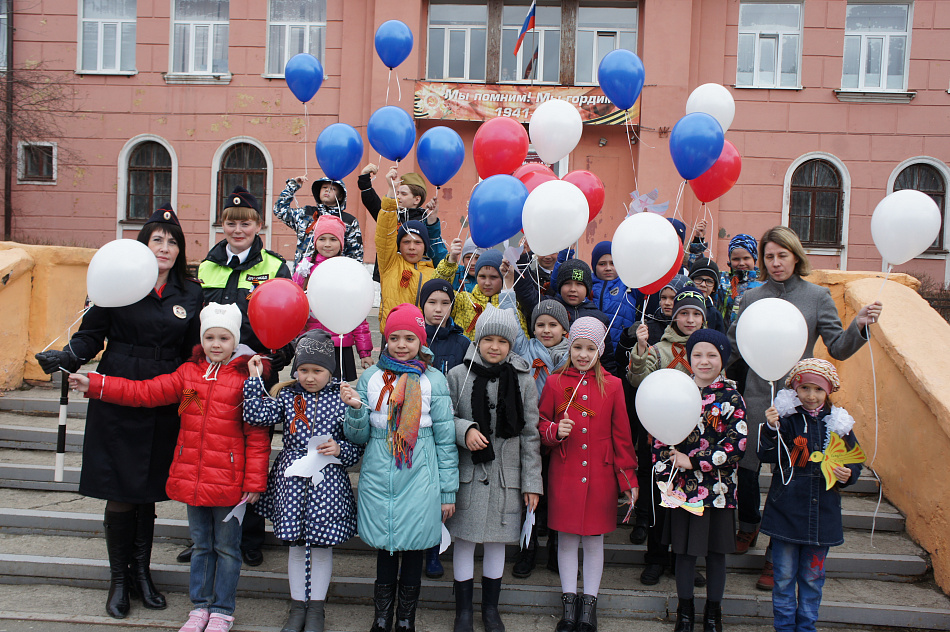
[736, 298, 808, 382]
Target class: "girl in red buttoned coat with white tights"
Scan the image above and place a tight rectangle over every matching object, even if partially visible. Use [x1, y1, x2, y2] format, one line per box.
[538, 316, 638, 632]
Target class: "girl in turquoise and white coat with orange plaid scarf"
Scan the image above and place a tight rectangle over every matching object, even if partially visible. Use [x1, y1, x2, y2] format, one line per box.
[340, 303, 459, 632]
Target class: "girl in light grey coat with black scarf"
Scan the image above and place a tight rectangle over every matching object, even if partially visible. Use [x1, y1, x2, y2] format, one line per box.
[446, 305, 542, 632]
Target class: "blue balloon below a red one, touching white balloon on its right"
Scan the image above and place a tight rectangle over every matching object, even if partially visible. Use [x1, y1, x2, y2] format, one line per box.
[468, 174, 528, 248]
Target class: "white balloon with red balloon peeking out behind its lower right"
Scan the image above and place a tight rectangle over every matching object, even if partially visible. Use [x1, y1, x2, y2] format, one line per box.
[610, 212, 680, 288]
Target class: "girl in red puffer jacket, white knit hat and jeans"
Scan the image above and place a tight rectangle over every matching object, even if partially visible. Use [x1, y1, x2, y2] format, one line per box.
[69, 303, 270, 632]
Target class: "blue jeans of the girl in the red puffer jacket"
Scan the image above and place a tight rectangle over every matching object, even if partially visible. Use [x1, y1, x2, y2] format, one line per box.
[188, 505, 241, 616]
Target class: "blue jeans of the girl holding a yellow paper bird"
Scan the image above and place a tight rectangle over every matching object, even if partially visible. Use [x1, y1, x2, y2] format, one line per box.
[771, 538, 828, 632]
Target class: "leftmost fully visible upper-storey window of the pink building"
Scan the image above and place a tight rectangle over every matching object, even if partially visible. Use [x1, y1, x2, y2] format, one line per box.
[79, 0, 136, 73]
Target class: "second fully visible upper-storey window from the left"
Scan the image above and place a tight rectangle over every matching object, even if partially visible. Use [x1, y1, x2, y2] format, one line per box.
[172, 0, 229, 75]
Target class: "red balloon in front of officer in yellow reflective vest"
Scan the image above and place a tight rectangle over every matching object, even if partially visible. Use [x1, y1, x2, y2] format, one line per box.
[247, 279, 310, 349]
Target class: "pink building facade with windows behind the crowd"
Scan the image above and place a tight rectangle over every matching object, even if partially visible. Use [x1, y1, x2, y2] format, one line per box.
[7, 0, 950, 282]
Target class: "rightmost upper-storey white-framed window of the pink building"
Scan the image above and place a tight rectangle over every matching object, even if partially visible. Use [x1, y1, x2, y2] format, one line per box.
[841, 3, 910, 91]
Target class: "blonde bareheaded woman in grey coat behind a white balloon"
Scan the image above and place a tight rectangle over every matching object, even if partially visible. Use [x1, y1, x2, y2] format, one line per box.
[729, 226, 881, 590]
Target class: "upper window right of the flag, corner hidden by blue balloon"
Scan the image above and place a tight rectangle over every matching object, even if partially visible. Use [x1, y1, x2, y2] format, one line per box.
[574, 4, 637, 84]
